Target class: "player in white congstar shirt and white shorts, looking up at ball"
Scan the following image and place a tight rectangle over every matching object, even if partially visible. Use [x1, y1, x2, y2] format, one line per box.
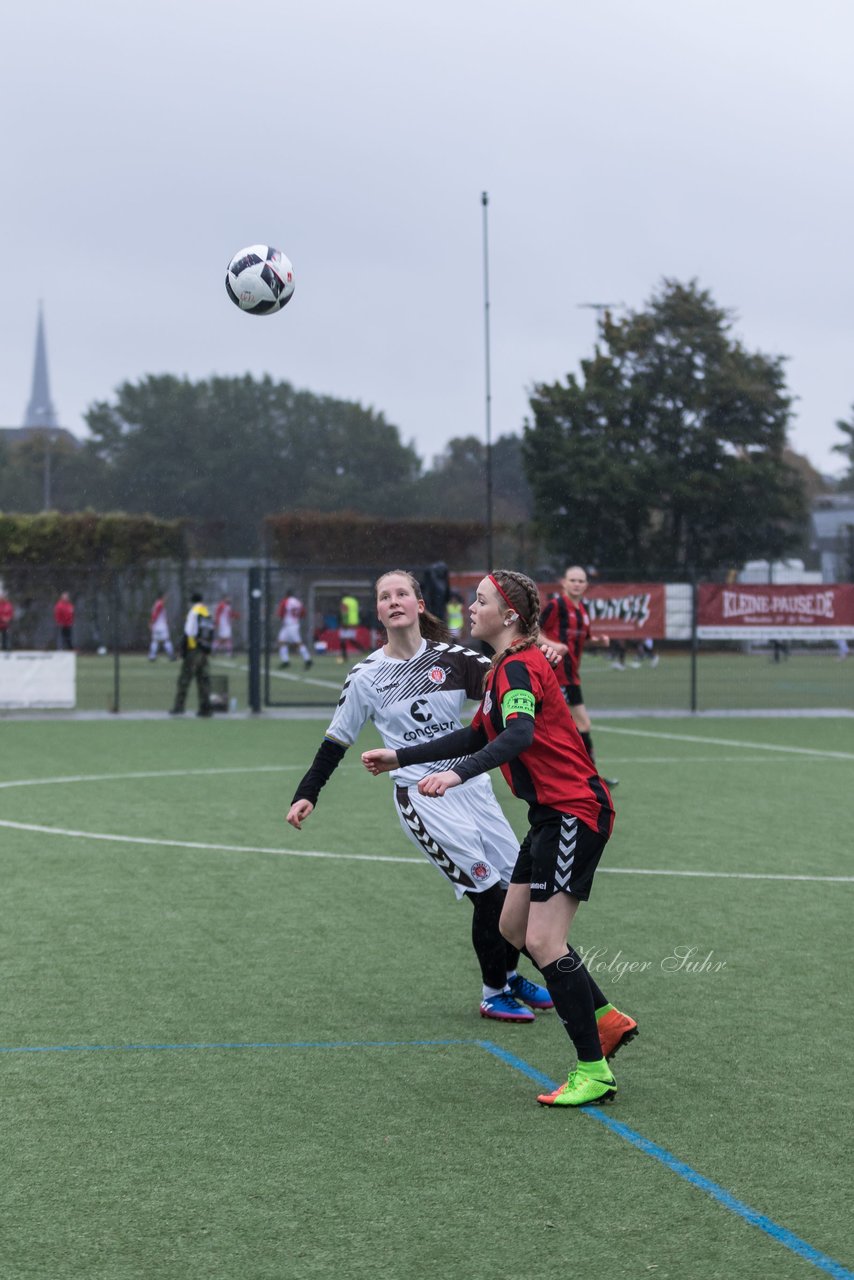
[287, 570, 552, 1023]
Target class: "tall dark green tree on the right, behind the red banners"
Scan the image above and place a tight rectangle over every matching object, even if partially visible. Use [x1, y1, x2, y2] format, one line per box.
[524, 280, 807, 575]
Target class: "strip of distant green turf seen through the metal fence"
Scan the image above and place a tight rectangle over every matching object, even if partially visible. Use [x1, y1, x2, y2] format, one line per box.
[11, 649, 854, 716]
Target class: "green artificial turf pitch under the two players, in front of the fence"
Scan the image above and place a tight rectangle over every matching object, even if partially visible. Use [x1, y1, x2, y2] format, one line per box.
[0, 716, 854, 1280]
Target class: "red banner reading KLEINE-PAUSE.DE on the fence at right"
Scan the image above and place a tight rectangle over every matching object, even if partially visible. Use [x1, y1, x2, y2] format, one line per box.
[697, 582, 854, 640]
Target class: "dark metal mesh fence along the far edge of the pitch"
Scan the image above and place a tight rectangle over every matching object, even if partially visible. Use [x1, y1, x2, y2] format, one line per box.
[0, 561, 854, 714]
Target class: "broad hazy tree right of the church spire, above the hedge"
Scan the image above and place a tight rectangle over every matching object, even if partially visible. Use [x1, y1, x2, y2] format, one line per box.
[86, 375, 420, 553]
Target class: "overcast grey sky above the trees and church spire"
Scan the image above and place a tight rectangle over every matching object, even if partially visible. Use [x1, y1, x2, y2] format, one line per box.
[0, 0, 854, 471]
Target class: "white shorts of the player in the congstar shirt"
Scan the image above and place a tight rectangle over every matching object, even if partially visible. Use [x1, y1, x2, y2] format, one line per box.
[394, 774, 519, 897]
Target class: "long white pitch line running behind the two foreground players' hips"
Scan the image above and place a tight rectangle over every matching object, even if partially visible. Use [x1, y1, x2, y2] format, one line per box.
[0, 819, 854, 884]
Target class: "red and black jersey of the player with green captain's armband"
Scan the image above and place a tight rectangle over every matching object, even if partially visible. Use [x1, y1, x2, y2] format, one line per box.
[471, 646, 613, 836]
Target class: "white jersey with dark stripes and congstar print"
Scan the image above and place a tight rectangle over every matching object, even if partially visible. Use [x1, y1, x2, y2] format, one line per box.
[326, 640, 489, 787]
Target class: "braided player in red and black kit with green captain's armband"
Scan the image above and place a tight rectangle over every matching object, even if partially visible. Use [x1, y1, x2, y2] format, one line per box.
[362, 570, 638, 1107]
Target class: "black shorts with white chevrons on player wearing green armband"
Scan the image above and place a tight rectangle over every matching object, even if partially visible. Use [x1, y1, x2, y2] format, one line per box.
[511, 809, 608, 902]
